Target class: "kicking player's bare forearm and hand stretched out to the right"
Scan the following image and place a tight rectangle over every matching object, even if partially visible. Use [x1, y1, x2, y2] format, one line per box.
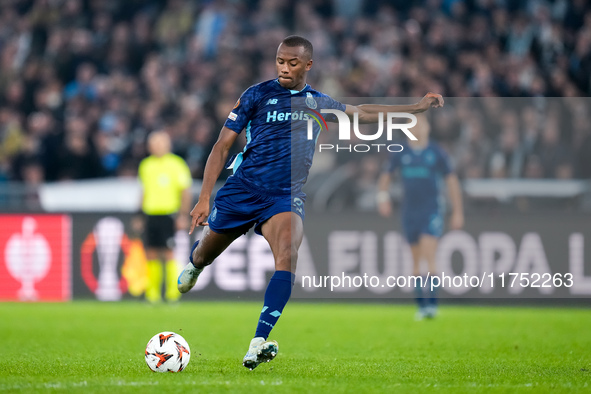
[345, 92, 443, 123]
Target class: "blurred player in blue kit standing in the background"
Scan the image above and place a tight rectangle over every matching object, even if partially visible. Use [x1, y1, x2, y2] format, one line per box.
[377, 115, 464, 320]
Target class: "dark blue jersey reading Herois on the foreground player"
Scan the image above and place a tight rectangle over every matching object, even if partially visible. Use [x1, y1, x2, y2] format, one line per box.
[225, 79, 345, 195]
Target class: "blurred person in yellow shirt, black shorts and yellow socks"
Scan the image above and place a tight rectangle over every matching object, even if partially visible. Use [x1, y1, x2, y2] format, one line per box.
[138, 131, 192, 302]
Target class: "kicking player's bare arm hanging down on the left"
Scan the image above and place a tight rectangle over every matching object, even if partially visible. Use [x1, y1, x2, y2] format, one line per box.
[189, 126, 238, 234]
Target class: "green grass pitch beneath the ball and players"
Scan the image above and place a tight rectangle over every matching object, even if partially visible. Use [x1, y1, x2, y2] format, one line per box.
[0, 301, 591, 393]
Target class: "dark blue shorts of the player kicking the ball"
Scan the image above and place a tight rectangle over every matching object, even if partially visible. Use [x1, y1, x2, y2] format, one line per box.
[207, 176, 306, 235]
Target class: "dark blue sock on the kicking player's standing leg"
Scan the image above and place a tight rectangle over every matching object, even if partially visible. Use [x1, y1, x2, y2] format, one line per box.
[254, 271, 295, 339]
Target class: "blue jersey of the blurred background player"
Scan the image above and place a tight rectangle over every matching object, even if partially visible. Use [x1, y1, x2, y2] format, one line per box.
[386, 142, 452, 216]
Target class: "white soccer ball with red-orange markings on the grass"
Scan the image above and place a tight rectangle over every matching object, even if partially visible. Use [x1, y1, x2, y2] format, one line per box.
[146, 331, 191, 372]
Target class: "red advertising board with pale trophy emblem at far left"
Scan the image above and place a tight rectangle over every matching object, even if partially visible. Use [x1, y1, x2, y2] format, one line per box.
[0, 215, 72, 301]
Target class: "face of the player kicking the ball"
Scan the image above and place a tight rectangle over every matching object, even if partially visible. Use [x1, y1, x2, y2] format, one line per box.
[275, 44, 312, 90]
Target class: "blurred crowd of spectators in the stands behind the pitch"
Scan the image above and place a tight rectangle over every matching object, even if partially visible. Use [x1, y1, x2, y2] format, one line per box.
[0, 0, 591, 189]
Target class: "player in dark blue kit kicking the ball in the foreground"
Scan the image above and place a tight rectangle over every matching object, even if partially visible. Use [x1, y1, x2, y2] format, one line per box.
[178, 36, 443, 370]
